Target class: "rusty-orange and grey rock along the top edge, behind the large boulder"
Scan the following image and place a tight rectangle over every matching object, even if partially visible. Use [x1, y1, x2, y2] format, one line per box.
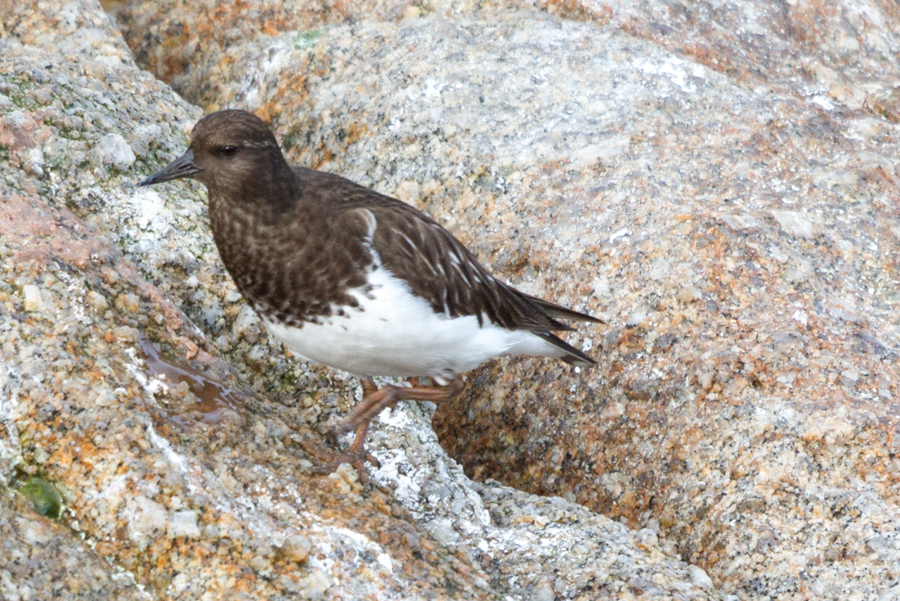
[110, 0, 900, 122]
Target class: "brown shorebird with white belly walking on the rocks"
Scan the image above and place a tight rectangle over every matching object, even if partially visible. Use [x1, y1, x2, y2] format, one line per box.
[138, 109, 603, 481]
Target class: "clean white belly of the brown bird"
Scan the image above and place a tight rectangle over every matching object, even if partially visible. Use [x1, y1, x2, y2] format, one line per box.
[265, 267, 562, 378]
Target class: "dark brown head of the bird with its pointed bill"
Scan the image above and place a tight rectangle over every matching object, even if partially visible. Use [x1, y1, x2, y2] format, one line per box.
[138, 109, 290, 198]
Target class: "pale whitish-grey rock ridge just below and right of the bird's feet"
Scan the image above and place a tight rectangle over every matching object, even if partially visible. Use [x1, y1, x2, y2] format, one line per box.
[373, 400, 717, 601]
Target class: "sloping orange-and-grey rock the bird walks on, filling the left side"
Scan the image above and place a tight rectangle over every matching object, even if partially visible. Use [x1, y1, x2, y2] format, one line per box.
[0, 0, 717, 600]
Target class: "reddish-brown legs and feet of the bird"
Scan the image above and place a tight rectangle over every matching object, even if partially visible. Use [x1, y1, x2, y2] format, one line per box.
[303, 377, 462, 482]
